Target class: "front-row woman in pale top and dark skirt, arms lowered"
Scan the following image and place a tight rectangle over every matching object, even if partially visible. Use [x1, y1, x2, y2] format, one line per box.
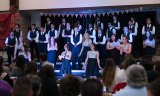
[85, 44, 102, 78]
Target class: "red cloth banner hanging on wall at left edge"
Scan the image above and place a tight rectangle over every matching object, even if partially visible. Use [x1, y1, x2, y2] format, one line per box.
[0, 13, 11, 49]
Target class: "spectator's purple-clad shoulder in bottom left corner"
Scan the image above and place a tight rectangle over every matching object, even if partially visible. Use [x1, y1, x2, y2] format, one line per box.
[0, 80, 12, 96]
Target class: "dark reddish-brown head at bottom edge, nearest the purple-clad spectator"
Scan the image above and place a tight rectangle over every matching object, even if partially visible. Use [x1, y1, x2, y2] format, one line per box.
[13, 77, 32, 96]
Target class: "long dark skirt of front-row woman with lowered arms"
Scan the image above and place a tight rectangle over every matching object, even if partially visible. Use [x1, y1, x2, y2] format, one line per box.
[86, 58, 99, 77]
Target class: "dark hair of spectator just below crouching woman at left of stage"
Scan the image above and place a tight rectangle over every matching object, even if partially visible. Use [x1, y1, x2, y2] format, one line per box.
[24, 61, 37, 75]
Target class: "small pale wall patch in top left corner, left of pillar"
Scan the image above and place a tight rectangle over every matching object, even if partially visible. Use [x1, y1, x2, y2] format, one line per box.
[0, 0, 10, 11]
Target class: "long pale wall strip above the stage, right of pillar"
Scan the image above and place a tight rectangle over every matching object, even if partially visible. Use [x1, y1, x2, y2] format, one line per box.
[19, 0, 160, 10]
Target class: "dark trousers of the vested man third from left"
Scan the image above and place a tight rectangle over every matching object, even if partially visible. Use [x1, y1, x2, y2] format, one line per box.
[29, 41, 39, 61]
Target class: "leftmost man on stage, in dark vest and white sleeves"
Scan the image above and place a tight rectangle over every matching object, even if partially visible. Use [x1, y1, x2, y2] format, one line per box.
[5, 32, 17, 64]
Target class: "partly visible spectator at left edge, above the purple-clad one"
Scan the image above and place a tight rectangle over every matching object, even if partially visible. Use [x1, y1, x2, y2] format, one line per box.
[0, 56, 13, 86]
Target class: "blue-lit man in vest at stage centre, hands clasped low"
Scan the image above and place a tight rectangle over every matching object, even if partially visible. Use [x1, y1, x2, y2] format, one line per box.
[71, 26, 82, 69]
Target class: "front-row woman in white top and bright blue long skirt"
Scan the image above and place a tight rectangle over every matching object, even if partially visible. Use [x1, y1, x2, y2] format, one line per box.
[58, 44, 72, 76]
